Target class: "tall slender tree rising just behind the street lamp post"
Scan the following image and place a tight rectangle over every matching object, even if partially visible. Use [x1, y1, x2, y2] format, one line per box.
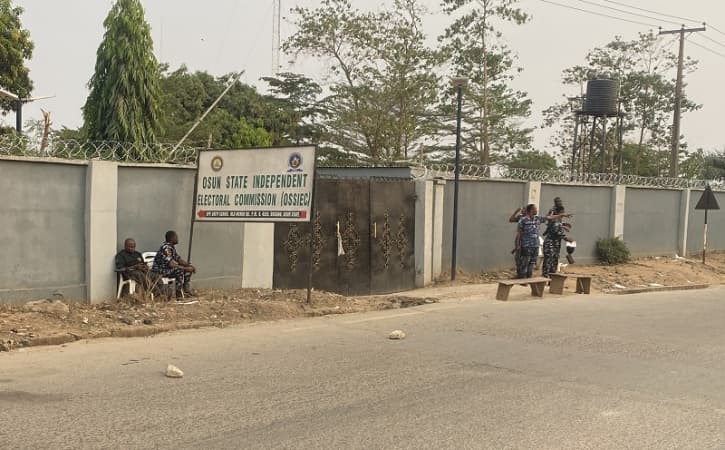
[439, 0, 531, 165]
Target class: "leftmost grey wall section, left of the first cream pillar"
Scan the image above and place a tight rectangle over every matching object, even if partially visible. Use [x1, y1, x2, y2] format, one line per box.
[0, 159, 86, 302]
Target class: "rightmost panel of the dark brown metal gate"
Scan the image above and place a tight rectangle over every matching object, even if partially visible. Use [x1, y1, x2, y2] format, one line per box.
[370, 180, 416, 294]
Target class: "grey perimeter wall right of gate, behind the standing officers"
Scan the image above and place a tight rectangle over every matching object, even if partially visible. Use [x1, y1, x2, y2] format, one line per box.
[434, 180, 725, 276]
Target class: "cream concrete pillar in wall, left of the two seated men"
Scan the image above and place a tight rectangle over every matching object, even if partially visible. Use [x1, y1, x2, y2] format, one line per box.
[85, 160, 118, 303]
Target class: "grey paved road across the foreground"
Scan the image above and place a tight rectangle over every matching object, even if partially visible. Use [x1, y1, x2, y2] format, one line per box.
[0, 287, 725, 449]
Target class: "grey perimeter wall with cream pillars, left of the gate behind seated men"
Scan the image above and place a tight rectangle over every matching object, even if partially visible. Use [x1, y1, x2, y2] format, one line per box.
[0, 157, 274, 303]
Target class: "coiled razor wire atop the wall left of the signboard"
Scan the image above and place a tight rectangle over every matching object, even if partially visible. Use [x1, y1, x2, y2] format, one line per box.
[0, 135, 197, 164]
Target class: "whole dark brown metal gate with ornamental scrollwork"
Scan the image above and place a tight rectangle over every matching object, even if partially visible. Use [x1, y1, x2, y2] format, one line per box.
[273, 178, 415, 295]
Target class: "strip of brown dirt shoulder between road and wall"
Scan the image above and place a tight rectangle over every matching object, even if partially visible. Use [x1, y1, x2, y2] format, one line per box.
[0, 253, 725, 351]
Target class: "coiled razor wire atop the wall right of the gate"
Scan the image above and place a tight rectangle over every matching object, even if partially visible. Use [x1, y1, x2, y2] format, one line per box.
[413, 164, 725, 190]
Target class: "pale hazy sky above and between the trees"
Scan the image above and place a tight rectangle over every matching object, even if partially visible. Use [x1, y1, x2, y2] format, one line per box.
[8, 0, 725, 156]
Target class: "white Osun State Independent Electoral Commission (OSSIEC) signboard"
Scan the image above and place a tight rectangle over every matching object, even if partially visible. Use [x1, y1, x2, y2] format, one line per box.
[194, 146, 315, 222]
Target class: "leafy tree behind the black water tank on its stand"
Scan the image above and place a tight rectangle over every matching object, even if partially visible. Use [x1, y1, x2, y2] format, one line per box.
[544, 31, 699, 175]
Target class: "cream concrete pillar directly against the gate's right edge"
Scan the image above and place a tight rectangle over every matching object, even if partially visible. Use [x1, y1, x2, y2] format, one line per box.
[414, 180, 433, 287]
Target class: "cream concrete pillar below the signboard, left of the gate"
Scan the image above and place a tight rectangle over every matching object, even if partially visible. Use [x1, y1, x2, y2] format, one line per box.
[242, 223, 274, 289]
